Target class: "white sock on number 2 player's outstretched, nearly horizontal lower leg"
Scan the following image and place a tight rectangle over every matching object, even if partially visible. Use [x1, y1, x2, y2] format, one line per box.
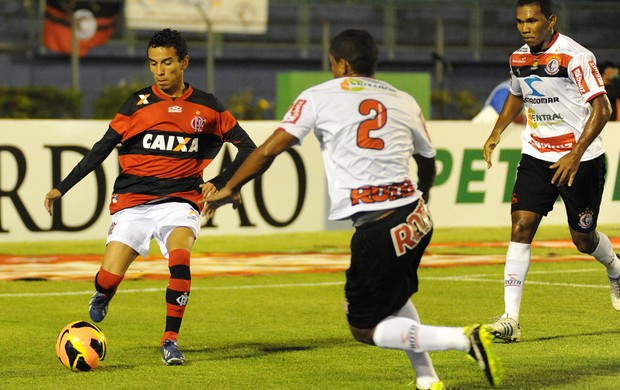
[373, 317, 471, 352]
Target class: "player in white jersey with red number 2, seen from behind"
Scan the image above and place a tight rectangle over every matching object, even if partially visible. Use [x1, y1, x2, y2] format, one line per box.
[205, 30, 501, 389]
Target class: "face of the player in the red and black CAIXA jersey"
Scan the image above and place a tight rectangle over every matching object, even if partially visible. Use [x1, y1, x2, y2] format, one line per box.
[148, 47, 189, 97]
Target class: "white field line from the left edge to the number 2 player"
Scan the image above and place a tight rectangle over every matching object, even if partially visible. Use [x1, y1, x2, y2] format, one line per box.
[0, 282, 344, 298]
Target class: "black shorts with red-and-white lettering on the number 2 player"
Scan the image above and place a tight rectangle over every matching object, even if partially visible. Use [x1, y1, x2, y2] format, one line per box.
[344, 200, 433, 329]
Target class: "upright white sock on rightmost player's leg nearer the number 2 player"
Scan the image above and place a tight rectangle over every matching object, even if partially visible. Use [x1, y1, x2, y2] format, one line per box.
[504, 241, 531, 322]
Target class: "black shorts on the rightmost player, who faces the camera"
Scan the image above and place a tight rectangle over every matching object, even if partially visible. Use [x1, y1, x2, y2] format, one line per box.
[511, 154, 607, 233]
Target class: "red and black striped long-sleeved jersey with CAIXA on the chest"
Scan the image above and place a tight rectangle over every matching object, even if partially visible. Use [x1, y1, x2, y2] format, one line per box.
[56, 84, 256, 214]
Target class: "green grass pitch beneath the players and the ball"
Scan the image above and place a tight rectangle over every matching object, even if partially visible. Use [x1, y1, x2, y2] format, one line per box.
[0, 227, 620, 389]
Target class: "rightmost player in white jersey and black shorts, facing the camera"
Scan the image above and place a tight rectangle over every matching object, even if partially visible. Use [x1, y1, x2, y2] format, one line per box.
[484, 0, 620, 341]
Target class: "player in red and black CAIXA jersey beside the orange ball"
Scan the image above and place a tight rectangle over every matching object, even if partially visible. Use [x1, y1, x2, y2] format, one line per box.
[45, 29, 256, 365]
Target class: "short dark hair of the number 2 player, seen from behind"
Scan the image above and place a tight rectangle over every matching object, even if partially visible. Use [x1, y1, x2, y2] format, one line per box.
[329, 30, 379, 76]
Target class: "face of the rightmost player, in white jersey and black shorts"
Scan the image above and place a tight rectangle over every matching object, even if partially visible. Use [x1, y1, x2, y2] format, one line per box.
[517, 4, 556, 50]
